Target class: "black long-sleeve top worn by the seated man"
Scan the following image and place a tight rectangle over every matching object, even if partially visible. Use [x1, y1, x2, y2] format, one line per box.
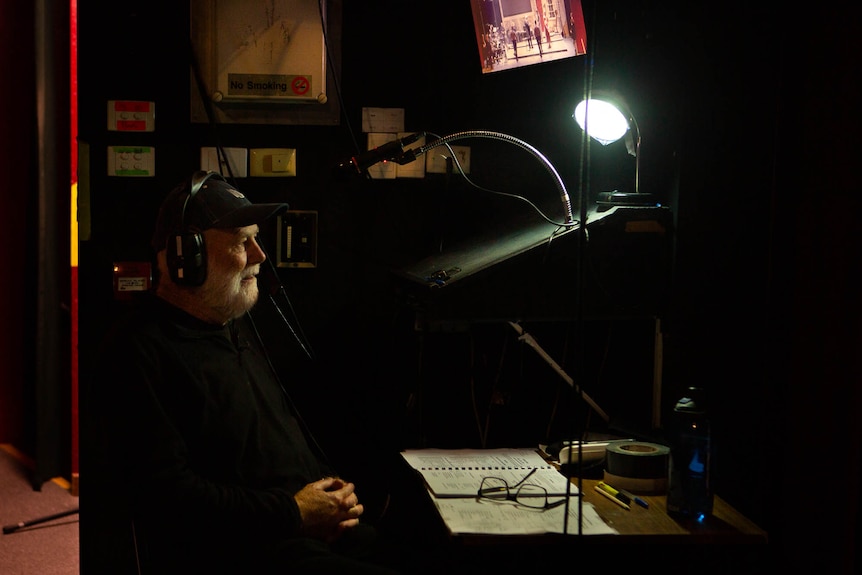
[94, 298, 331, 567]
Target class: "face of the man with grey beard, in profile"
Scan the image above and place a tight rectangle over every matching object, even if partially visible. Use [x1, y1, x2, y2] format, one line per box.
[200, 225, 266, 322]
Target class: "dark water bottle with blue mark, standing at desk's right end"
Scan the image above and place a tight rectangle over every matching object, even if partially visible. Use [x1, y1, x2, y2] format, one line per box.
[667, 387, 713, 522]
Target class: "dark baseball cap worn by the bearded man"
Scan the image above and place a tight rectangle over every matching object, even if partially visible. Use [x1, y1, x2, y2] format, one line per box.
[151, 171, 289, 251]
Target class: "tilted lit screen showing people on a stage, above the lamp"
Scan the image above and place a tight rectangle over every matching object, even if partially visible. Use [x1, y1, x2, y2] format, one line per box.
[470, 0, 587, 74]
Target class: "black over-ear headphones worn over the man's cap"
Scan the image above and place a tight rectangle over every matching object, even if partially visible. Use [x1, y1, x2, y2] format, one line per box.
[166, 171, 226, 286]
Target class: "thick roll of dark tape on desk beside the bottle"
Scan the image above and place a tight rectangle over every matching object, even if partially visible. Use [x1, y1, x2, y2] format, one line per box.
[605, 441, 670, 493]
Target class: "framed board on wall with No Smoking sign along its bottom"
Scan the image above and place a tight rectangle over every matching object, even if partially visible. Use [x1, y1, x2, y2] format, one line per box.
[191, 0, 340, 124]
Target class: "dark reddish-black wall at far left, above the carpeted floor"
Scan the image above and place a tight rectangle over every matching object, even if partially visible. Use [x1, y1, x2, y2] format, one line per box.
[0, 2, 72, 489]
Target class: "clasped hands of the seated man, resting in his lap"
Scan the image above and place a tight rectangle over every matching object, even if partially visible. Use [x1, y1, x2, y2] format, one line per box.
[294, 477, 365, 543]
